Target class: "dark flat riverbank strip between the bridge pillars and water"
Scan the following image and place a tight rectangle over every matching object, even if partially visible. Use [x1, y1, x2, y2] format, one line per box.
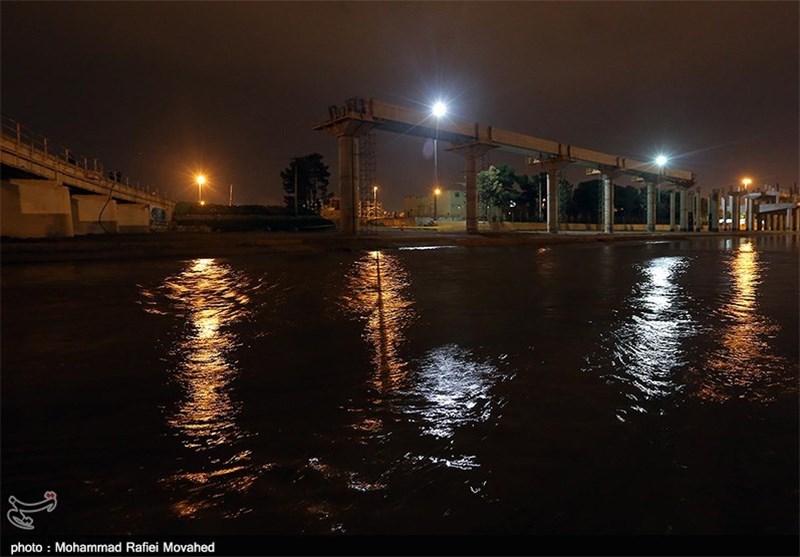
[0, 229, 796, 264]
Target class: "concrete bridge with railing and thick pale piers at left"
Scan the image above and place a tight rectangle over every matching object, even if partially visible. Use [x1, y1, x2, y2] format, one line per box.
[0, 115, 175, 238]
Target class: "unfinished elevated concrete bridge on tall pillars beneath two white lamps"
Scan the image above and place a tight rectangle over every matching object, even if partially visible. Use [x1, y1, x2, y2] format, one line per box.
[314, 98, 697, 234]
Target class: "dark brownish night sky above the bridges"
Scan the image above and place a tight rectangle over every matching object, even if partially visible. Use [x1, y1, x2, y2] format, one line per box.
[0, 0, 800, 209]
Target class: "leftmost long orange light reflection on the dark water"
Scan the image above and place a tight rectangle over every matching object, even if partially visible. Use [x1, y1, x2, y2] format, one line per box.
[141, 259, 274, 517]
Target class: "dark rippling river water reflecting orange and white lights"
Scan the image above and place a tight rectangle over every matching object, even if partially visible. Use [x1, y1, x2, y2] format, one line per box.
[2, 235, 800, 534]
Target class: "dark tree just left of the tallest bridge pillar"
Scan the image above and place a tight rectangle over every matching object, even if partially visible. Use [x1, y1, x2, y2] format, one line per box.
[281, 153, 333, 213]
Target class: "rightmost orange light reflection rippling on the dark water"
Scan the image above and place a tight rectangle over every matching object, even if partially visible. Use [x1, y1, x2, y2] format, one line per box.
[697, 239, 796, 402]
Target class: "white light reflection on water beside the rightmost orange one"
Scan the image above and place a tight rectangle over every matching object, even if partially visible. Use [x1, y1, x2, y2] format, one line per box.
[588, 256, 697, 421]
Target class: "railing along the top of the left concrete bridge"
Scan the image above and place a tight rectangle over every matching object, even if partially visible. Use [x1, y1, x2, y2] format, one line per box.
[2, 114, 166, 195]
